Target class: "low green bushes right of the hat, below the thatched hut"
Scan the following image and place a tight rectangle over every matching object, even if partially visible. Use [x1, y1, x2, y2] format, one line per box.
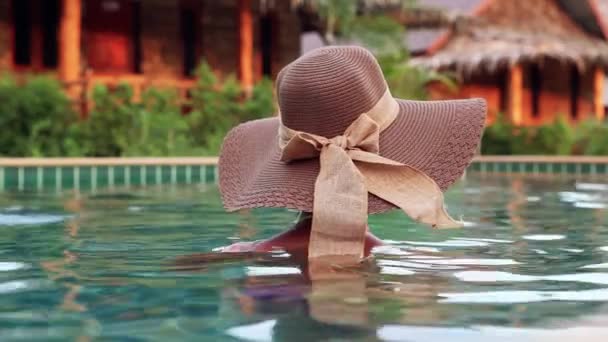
[481, 116, 608, 155]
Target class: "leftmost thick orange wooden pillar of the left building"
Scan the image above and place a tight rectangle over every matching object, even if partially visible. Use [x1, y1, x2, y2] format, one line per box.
[59, 0, 82, 98]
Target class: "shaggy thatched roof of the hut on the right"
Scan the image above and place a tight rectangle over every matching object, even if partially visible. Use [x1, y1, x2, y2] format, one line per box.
[413, 0, 608, 74]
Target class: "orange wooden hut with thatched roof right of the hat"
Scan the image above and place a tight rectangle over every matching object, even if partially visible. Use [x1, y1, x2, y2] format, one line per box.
[411, 0, 608, 125]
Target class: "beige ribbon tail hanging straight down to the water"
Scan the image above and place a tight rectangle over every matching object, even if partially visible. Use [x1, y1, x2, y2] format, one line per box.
[308, 145, 367, 264]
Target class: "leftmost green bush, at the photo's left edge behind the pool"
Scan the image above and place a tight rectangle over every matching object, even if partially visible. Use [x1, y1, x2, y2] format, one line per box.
[0, 75, 77, 157]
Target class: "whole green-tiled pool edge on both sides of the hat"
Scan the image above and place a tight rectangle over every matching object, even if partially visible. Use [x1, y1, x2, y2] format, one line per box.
[0, 156, 608, 192]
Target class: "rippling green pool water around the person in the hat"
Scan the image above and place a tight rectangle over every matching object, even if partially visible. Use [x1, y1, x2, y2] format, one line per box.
[0, 176, 608, 342]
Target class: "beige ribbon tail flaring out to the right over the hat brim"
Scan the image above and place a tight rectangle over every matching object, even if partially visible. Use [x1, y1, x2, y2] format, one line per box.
[355, 156, 463, 228]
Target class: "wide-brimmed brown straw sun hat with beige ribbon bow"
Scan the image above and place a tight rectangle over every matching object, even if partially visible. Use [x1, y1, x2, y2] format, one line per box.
[219, 47, 486, 262]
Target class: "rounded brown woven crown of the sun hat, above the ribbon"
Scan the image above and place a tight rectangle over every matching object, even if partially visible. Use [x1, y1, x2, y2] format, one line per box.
[277, 46, 386, 138]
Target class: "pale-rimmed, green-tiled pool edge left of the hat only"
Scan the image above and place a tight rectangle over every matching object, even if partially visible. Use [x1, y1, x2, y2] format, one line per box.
[0, 157, 219, 192]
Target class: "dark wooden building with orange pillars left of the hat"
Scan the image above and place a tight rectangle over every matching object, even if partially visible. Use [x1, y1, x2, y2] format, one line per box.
[0, 0, 301, 103]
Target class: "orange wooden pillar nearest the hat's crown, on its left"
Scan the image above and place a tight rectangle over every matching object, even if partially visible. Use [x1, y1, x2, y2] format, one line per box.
[239, 0, 253, 92]
